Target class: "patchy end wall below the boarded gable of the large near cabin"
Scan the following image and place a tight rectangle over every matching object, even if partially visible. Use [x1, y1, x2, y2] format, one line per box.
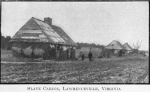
[12, 43, 48, 57]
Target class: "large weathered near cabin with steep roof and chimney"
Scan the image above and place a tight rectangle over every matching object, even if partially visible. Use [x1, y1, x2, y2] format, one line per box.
[11, 17, 76, 60]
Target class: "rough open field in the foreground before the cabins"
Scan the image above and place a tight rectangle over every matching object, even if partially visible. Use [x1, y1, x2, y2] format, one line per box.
[1, 50, 149, 83]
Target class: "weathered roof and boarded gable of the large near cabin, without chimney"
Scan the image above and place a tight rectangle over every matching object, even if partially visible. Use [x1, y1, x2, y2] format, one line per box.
[11, 17, 76, 46]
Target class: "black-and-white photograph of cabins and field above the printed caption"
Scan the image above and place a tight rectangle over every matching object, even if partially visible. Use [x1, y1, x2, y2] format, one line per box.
[1, 0, 149, 84]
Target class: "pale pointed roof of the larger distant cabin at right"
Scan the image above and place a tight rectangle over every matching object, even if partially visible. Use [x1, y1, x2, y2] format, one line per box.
[105, 40, 124, 49]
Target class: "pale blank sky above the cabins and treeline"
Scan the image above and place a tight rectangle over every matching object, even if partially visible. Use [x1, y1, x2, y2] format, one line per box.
[1, 1, 149, 50]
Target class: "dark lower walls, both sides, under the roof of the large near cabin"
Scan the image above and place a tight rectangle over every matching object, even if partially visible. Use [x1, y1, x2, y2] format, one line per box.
[12, 42, 75, 60]
